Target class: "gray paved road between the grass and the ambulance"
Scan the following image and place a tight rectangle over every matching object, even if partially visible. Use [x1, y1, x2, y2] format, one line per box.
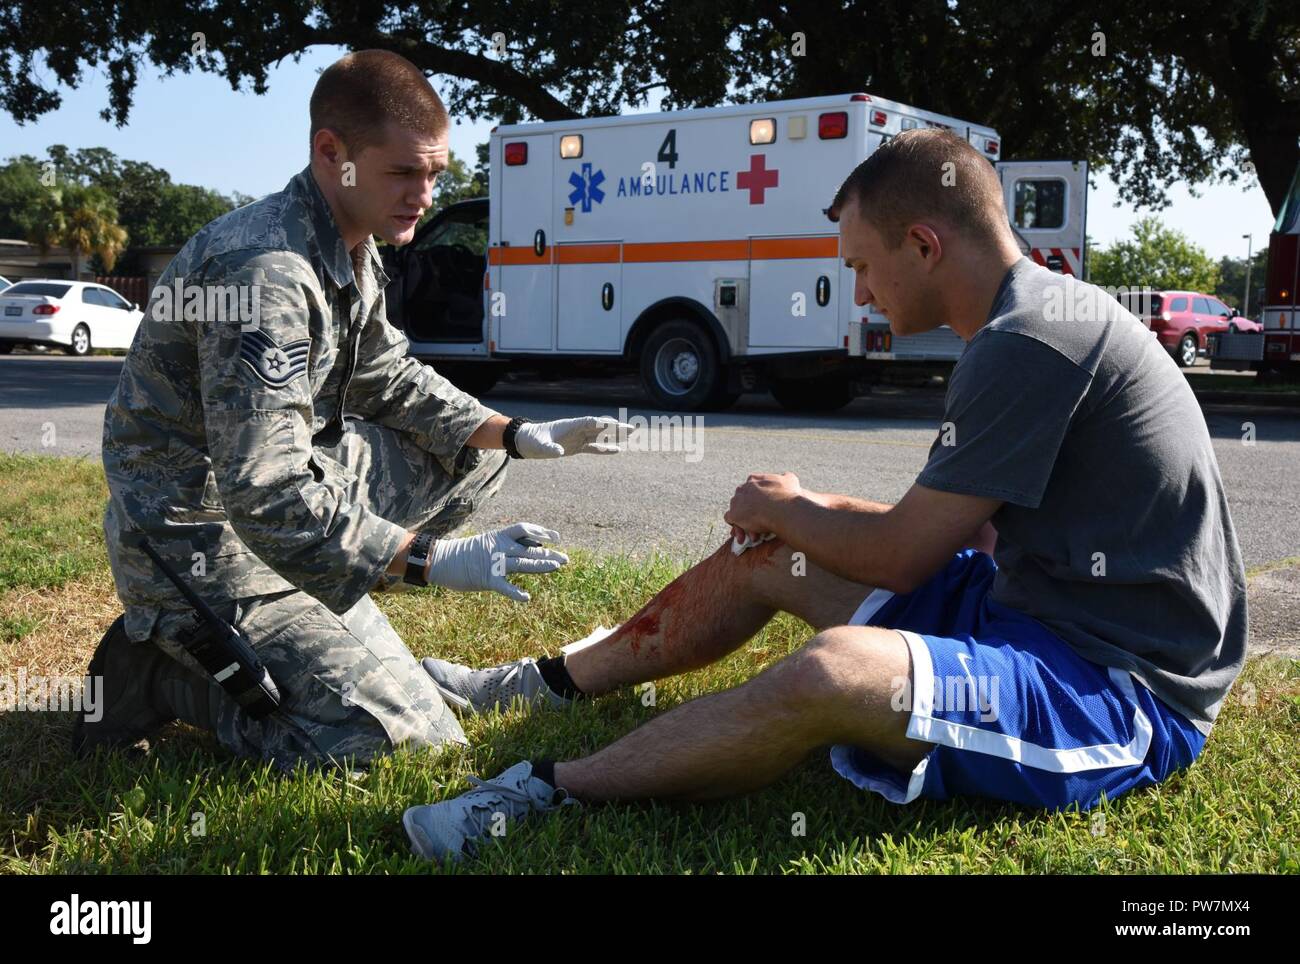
[0, 355, 1300, 566]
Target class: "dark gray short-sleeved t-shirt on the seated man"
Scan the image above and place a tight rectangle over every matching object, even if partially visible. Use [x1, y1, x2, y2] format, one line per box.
[917, 259, 1247, 734]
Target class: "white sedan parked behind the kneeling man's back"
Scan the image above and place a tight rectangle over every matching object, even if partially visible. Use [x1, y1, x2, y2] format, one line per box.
[0, 281, 144, 355]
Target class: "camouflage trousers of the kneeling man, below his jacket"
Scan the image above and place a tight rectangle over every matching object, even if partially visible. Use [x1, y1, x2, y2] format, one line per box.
[144, 421, 507, 769]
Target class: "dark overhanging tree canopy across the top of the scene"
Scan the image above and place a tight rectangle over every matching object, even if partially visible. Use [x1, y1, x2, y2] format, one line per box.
[0, 0, 1300, 213]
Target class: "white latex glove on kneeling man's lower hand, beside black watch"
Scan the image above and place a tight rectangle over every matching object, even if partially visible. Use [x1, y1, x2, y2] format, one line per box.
[429, 522, 568, 603]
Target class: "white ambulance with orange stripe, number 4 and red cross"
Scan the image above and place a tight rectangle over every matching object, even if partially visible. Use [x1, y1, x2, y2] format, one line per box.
[387, 94, 1087, 411]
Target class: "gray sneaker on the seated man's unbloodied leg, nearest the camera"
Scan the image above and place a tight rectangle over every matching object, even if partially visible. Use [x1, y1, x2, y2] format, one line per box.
[402, 760, 580, 860]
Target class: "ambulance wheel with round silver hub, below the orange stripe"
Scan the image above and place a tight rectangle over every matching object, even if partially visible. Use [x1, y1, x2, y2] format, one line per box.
[641, 321, 736, 412]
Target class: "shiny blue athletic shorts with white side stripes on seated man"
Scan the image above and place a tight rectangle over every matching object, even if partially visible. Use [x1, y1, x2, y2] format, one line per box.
[831, 550, 1205, 809]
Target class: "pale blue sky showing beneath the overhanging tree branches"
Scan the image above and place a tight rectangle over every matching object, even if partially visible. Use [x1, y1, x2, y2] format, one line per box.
[0, 47, 1273, 257]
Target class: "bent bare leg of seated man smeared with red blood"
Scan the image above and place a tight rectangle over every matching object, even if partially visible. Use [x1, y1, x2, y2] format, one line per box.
[564, 539, 871, 695]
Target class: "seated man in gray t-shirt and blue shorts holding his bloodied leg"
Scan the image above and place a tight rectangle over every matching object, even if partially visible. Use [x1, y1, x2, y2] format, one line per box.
[403, 130, 1247, 859]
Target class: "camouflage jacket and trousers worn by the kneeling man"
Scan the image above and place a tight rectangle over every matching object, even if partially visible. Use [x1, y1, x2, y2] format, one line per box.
[85, 160, 608, 767]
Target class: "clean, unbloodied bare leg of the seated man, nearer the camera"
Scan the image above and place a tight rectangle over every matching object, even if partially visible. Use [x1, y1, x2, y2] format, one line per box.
[555, 626, 931, 800]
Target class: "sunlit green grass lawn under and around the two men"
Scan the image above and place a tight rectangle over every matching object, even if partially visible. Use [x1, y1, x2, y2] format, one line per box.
[0, 453, 1300, 873]
